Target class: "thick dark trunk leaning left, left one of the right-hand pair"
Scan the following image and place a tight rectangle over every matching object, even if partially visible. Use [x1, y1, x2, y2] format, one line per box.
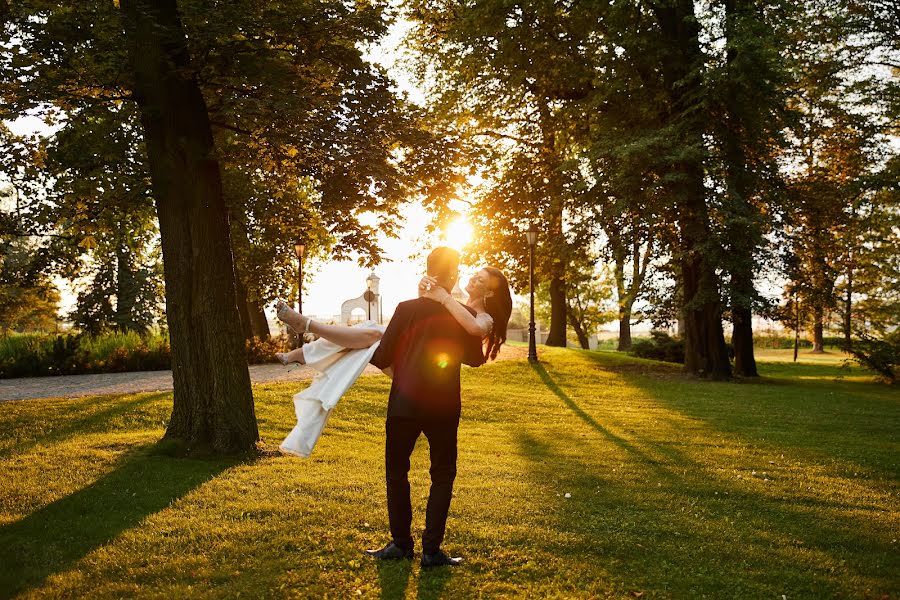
[652, 0, 731, 379]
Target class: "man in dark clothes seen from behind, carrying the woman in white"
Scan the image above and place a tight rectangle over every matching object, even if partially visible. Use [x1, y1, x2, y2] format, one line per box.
[366, 247, 484, 567]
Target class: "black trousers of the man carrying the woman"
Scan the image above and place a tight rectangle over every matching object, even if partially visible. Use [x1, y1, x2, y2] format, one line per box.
[384, 417, 459, 554]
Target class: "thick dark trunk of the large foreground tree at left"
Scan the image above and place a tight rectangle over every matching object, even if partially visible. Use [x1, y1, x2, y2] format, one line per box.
[121, 0, 259, 453]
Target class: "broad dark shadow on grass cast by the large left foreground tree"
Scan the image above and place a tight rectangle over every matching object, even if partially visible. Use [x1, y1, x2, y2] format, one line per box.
[0, 446, 237, 598]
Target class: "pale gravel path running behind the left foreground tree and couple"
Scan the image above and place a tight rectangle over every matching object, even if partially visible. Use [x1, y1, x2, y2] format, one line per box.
[0, 346, 527, 402]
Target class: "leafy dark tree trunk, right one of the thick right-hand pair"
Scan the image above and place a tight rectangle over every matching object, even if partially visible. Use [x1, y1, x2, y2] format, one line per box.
[706, 0, 791, 377]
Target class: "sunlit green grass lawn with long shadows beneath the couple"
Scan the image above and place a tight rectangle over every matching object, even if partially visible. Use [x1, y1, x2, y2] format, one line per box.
[0, 348, 900, 599]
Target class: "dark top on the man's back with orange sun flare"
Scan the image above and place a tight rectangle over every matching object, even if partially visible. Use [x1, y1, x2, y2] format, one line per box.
[370, 298, 484, 418]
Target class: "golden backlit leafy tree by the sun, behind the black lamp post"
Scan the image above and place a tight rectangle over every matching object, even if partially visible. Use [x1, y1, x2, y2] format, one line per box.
[407, 0, 596, 345]
